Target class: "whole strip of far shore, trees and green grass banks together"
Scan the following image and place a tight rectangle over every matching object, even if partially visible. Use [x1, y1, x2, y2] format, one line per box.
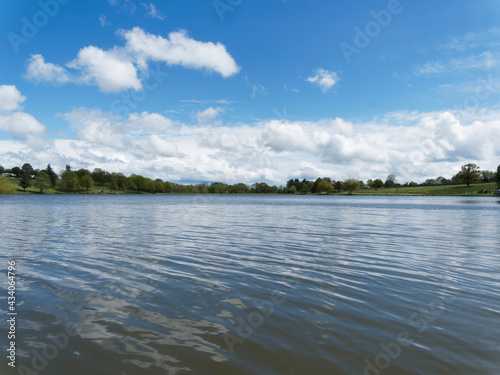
[0, 163, 500, 196]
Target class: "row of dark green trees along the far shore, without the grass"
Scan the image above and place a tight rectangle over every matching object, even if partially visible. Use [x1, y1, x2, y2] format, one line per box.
[0, 163, 500, 194]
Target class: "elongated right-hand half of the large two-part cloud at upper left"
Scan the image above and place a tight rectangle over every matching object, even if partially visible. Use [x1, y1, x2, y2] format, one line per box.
[119, 27, 240, 77]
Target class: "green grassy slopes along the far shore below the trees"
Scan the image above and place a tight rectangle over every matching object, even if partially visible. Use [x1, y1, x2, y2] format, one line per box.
[4, 179, 497, 196]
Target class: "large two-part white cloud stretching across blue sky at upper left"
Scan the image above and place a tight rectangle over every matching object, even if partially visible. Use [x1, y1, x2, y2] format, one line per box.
[25, 27, 240, 93]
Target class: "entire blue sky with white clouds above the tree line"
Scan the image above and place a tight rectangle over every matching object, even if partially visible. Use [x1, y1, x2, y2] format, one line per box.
[0, 0, 500, 185]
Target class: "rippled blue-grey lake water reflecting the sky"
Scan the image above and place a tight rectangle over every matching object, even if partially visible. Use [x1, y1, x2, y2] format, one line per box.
[0, 195, 500, 375]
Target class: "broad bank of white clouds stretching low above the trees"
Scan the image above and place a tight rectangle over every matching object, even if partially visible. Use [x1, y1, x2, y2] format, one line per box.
[0, 108, 500, 185]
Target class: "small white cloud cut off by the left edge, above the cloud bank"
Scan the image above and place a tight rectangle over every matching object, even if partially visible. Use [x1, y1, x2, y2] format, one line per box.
[0, 85, 46, 136]
